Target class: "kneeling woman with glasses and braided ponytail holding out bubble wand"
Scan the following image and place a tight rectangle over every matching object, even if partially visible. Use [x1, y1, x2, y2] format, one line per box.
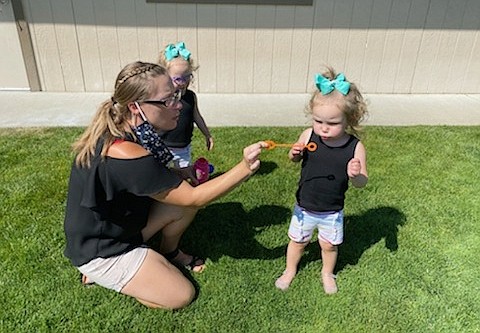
[64, 62, 266, 309]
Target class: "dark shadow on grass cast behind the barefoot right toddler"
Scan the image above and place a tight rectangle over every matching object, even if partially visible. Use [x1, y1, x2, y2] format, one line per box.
[299, 207, 406, 272]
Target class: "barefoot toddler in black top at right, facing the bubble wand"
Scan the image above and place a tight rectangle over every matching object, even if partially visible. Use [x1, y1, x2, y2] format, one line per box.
[275, 68, 368, 294]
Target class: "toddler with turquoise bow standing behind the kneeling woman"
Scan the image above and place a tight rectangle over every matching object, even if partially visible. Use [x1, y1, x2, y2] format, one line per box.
[158, 42, 213, 168]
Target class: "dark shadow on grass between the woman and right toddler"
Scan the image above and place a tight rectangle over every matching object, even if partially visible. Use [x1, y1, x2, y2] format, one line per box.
[182, 202, 291, 261]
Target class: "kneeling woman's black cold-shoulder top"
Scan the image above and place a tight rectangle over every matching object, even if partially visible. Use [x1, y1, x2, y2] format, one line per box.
[64, 136, 182, 266]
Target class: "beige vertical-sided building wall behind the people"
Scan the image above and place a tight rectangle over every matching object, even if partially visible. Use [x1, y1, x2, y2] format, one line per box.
[21, 0, 480, 94]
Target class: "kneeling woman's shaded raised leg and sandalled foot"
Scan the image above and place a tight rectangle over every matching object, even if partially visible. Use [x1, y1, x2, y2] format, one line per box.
[142, 203, 205, 272]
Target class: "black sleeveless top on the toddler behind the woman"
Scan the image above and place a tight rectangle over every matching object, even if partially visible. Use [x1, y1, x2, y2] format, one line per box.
[159, 89, 195, 148]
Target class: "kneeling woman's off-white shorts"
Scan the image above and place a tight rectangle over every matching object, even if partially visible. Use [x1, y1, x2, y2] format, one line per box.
[77, 247, 148, 292]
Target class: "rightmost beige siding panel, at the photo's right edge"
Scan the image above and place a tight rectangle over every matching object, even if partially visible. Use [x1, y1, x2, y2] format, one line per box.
[460, 0, 480, 94]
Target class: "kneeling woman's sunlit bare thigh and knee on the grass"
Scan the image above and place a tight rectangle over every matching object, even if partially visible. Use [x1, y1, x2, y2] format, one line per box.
[121, 249, 195, 309]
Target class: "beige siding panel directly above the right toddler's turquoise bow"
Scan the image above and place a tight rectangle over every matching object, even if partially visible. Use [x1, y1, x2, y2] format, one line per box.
[327, 0, 353, 72]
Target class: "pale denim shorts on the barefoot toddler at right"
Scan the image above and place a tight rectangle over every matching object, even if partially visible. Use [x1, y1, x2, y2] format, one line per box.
[288, 205, 343, 245]
